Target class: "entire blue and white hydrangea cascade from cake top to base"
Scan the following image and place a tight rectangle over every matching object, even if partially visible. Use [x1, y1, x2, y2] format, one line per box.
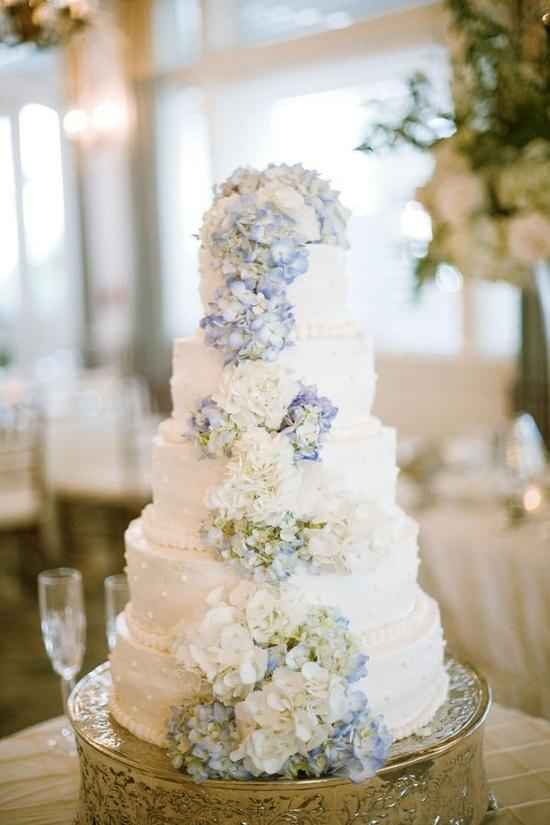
[167, 166, 391, 781]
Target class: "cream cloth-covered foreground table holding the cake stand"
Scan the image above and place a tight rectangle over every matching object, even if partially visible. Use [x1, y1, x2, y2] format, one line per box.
[0, 705, 550, 825]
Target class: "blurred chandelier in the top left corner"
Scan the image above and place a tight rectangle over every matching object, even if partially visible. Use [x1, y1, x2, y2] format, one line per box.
[0, 0, 93, 48]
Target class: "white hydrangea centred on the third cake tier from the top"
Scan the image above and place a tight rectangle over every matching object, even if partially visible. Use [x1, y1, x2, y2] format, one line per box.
[207, 427, 300, 523]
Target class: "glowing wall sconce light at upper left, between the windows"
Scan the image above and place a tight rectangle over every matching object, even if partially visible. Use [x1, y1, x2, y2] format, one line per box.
[63, 97, 130, 144]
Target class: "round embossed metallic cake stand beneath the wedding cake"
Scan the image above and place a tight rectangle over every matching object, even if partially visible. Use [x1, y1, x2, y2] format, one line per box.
[69, 659, 491, 825]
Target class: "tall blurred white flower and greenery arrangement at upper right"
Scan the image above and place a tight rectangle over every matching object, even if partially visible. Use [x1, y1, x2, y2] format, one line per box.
[359, 0, 550, 286]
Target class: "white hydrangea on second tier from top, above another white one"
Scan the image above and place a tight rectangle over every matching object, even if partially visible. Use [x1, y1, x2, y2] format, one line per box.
[214, 361, 299, 430]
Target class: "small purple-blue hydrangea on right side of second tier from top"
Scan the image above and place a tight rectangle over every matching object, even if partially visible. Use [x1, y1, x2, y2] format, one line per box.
[281, 384, 338, 461]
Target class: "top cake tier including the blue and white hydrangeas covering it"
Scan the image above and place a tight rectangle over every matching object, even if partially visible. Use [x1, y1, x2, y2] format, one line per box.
[200, 165, 350, 362]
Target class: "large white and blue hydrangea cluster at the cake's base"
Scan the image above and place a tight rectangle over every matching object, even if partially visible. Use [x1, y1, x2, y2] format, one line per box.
[168, 582, 391, 781]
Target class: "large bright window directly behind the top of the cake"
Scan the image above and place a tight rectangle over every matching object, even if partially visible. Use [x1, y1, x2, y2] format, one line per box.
[153, 0, 519, 357]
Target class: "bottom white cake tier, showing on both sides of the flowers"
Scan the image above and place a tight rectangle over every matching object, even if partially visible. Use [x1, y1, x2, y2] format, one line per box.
[111, 589, 448, 746]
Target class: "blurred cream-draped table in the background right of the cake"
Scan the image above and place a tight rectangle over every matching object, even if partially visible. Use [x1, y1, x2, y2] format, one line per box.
[417, 503, 550, 716]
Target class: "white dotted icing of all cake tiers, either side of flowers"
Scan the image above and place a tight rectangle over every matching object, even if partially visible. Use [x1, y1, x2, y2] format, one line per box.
[111, 174, 448, 760]
